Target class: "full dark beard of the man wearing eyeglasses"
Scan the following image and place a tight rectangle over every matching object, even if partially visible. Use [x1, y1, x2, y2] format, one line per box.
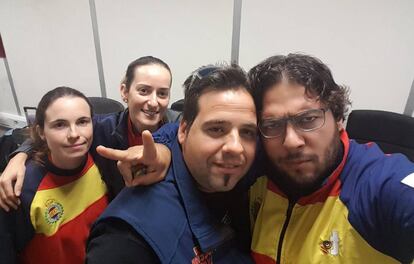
[265, 130, 343, 200]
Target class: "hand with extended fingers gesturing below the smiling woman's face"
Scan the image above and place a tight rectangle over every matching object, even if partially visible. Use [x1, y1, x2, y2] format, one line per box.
[96, 131, 171, 186]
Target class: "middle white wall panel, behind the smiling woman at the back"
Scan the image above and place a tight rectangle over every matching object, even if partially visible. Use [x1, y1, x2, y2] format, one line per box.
[95, 0, 233, 103]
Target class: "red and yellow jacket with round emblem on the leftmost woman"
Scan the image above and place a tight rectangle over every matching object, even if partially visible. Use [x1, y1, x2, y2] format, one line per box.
[0, 155, 108, 263]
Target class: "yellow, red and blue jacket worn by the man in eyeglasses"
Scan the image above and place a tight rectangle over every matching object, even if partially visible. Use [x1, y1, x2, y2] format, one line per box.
[250, 132, 414, 264]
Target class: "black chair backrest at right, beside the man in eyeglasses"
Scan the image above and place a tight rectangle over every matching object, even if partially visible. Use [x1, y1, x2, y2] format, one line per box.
[346, 110, 414, 161]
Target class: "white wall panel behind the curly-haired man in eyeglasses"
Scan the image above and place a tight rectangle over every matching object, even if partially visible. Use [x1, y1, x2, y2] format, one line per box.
[240, 0, 414, 113]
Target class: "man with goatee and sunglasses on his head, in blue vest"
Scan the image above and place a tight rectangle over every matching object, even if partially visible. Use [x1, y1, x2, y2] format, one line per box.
[86, 65, 257, 264]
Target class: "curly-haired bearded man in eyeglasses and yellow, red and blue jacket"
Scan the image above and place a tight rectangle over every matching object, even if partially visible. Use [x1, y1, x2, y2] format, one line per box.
[249, 54, 414, 264]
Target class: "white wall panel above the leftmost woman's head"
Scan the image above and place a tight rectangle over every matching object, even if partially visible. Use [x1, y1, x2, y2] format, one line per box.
[0, 0, 100, 112]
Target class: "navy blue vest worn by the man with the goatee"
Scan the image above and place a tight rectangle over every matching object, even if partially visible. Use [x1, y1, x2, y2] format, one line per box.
[90, 140, 252, 263]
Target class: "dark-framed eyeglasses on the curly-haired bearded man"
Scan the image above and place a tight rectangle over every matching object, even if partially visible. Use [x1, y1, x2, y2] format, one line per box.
[259, 108, 328, 138]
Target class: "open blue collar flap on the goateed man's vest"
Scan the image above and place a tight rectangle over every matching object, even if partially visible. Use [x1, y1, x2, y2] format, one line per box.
[171, 140, 234, 252]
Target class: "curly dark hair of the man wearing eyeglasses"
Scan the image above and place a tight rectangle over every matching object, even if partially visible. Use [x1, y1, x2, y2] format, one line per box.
[248, 53, 351, 121]
